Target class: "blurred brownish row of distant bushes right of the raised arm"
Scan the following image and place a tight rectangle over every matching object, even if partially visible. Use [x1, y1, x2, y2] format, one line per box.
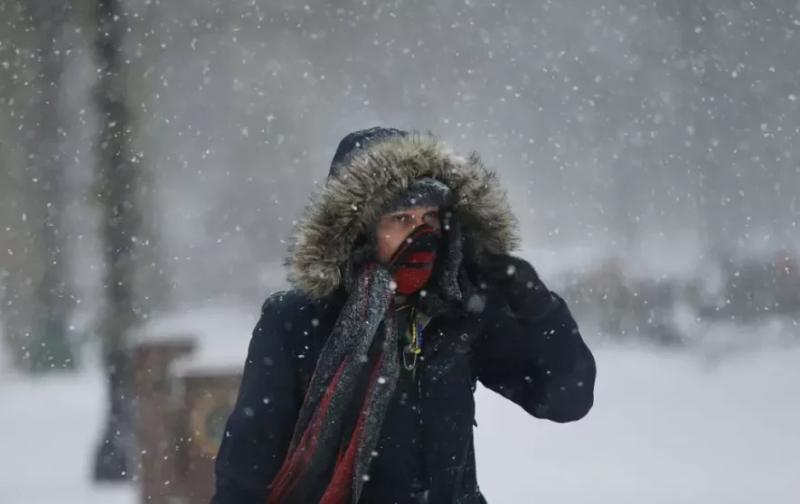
[562, 251, 800, 347]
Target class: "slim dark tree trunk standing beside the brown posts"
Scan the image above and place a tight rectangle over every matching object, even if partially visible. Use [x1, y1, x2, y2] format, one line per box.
[95, 0, 140, 480]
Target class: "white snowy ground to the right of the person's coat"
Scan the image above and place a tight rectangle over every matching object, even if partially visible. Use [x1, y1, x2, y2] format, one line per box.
[476, 348, 800, 504]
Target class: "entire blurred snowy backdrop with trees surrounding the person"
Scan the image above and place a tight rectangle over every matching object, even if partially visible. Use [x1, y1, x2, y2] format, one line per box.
[0, 0, 800, 504]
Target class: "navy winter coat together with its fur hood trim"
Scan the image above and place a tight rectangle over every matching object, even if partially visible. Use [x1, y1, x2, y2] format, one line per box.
[214, 132, 595, 504]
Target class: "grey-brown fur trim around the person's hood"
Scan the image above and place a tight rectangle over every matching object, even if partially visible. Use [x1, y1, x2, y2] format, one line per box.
[286, 133, 519, 299]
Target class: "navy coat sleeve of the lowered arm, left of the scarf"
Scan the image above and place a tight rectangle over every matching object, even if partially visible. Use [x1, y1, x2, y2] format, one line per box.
[212, 293, 300, 504]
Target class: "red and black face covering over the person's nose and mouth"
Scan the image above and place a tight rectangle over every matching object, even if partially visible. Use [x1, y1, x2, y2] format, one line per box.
[389, 224, 441, 296]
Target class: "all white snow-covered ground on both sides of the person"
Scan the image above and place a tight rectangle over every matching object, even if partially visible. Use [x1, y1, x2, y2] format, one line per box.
[0, 340, 800, 504]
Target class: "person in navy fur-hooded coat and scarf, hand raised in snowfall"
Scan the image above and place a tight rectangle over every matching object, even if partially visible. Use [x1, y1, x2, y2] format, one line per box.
[213, 127, 595, 504]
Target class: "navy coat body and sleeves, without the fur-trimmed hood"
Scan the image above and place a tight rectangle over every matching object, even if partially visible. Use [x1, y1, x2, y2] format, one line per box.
[214, 284, 595, 504]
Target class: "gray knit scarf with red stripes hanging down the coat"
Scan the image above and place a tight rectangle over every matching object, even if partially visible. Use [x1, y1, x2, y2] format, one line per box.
[268, 262, 400, 504]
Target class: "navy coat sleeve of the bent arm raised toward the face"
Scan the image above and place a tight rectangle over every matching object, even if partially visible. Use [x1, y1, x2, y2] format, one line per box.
[475, 285, 596, 422]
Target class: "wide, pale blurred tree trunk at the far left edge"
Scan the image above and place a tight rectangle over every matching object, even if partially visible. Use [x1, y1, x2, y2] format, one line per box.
[0, 0, 75, 371]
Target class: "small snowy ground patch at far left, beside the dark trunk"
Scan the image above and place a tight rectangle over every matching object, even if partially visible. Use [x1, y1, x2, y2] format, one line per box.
[0, 370, 136, 504]
